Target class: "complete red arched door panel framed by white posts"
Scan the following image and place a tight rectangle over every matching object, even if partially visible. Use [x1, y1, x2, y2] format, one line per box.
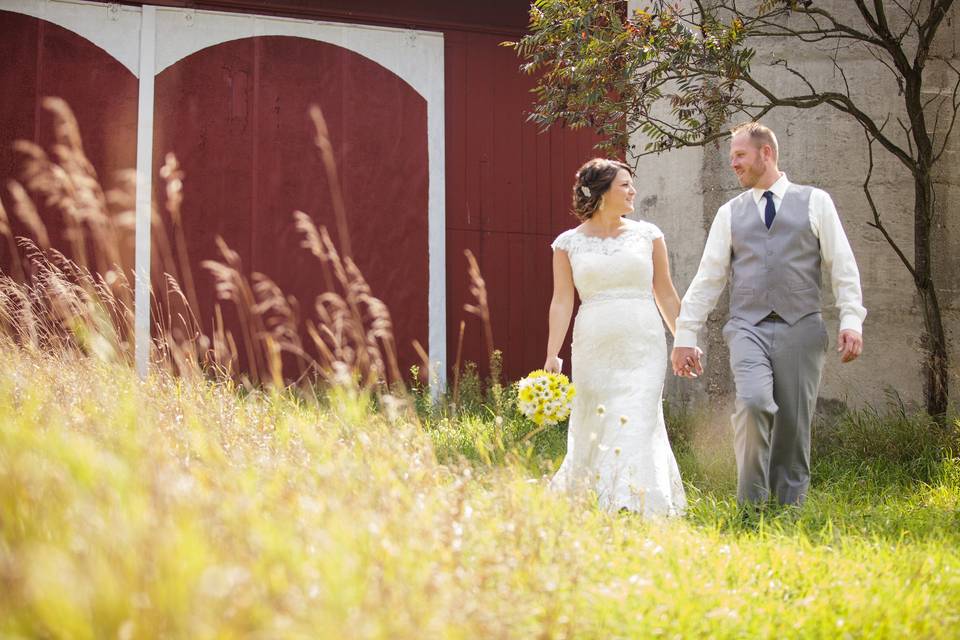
[154, 36, 428, 376]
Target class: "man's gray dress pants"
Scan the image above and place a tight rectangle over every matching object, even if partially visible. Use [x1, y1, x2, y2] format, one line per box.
[723, 313, 828, 504]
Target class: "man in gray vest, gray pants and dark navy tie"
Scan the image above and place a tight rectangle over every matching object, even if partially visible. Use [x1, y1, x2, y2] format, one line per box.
[671, 122, 867, 505]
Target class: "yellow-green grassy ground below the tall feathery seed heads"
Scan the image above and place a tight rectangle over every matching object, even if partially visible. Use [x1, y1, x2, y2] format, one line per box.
[0, 347, 960, 638]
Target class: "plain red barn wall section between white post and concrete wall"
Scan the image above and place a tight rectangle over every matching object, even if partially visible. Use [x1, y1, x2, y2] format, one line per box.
[444, 31, 596, 379]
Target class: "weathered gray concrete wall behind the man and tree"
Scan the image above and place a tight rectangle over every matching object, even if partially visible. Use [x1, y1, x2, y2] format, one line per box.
[630, 0, 960, 410]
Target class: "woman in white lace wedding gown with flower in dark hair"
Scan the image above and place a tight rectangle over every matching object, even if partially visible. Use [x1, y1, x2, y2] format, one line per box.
[543, 158, 692, 516]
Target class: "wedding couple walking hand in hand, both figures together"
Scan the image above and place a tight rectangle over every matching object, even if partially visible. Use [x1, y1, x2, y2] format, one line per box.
[544, 122, 867, 515]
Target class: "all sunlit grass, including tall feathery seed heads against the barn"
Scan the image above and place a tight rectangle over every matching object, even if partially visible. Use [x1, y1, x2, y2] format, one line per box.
[0, 95, 960, 639]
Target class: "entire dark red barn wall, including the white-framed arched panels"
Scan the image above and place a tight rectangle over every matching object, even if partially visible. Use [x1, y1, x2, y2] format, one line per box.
[0, 0, 595, 378]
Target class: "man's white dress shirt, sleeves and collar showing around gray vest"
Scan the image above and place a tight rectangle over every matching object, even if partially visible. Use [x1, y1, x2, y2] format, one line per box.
[673, 173, 867, 347]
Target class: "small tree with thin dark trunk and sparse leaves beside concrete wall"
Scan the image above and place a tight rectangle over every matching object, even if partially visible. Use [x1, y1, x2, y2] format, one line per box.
[511, 0, 960, 415]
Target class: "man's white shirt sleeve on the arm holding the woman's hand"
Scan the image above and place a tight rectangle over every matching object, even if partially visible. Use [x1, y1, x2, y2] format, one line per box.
[673, 204, 730, 347]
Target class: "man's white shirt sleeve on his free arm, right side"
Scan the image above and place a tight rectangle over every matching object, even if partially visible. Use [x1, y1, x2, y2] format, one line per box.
[810, 189, 867, 335]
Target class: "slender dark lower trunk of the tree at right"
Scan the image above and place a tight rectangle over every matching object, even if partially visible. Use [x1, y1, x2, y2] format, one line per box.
[914, 170, 949, 424]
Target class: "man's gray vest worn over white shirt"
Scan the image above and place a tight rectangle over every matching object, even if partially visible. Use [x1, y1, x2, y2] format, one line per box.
[730, 184, 821, 324]
